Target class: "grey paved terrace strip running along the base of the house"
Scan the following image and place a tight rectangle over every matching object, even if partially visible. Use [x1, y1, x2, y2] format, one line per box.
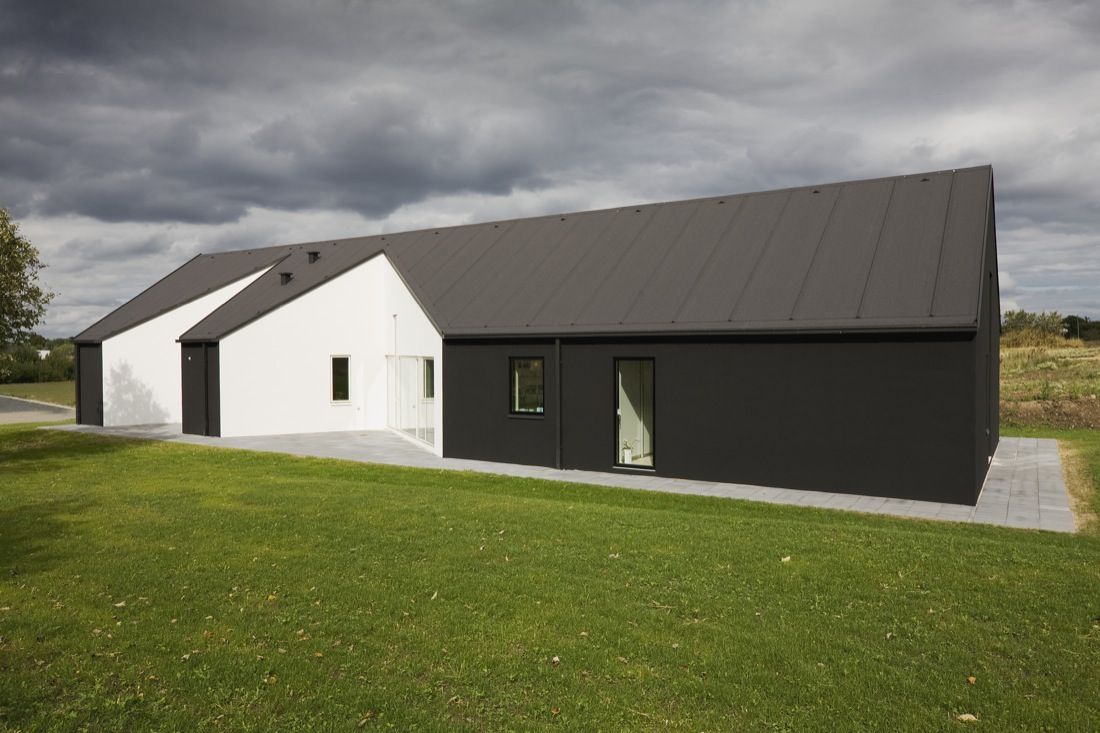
[52, 424, 1075, 532]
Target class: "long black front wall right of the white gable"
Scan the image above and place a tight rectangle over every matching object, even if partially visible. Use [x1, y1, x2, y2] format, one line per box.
[443, 335, 985, 504]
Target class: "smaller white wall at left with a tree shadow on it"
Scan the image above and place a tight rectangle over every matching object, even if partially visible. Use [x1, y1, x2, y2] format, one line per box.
[103, 267, 267, 426]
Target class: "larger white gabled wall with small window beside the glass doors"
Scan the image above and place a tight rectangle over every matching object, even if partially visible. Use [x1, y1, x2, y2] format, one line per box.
[219, 254, 443, 455]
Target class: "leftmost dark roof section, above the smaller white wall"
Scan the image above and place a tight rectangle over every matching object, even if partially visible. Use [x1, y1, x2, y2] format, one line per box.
[74, 247, 290, 342]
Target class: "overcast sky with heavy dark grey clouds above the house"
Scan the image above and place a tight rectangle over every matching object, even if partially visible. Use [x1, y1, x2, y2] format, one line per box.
[0, 0, 1100, 336]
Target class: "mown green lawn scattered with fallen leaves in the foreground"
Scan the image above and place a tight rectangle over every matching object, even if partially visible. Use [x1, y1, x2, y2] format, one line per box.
[0, 426, 1100, 731]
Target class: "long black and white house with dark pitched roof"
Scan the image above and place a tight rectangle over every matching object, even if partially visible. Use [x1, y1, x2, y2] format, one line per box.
[77, 166, 1000, 504]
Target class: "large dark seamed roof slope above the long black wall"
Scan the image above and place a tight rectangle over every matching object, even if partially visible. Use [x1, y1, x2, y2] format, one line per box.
[81, 165, 992, 341]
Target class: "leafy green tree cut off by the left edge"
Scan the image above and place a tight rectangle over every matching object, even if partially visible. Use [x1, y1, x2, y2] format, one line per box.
[0, 208, 54, 349]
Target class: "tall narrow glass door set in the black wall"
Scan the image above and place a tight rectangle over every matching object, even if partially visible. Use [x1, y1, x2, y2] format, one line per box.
[615, 359, 653, 468]
